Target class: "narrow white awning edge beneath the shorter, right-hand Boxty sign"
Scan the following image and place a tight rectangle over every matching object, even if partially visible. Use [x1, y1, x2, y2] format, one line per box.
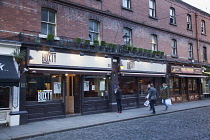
[121, 72, 166, 77]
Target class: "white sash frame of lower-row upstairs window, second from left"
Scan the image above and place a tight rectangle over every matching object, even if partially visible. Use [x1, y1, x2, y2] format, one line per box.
[88, 20, 100, 44]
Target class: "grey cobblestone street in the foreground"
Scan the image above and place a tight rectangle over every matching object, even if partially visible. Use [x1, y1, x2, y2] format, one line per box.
[24, 107, 210, 140]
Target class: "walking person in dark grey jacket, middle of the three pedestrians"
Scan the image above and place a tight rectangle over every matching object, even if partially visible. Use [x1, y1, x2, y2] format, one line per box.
[148, 84, 157, 114]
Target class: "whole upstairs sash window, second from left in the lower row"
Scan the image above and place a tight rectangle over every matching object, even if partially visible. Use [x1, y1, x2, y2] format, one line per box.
[89, 20, 99, 43]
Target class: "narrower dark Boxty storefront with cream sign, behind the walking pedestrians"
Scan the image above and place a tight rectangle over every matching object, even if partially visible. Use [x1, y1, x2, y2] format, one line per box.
[118, 59, 166, 109]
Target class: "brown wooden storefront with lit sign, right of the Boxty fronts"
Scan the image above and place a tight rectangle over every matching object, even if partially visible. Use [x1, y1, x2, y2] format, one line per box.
[169, 65, 207, 103]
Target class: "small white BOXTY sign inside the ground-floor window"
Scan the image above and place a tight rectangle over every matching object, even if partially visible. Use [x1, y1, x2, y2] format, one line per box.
[37, 90, 52, 102]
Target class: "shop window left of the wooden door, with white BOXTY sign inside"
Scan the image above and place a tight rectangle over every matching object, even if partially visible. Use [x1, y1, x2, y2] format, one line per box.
[26, 74, 63, 102]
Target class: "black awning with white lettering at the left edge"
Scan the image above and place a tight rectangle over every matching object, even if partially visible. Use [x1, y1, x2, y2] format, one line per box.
[0, 55, 20, 87]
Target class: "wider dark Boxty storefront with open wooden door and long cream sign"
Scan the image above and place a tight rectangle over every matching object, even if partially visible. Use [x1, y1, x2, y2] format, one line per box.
[21, 50, 112, 122]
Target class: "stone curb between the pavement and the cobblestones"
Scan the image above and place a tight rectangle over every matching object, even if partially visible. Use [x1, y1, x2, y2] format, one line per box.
[11, 105, 210, 140]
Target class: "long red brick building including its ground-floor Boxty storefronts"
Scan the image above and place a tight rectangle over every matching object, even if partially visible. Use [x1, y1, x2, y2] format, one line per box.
[0, 0, 210, 125]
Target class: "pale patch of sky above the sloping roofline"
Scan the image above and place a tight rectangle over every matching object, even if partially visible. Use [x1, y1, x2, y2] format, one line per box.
[182, 0, 210, 14]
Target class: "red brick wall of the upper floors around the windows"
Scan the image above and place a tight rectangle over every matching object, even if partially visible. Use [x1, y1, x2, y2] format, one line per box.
[0, 0, 210, 61]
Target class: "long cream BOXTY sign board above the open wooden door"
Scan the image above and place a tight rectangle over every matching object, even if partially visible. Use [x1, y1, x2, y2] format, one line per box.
[29, 50, 112, 70]
